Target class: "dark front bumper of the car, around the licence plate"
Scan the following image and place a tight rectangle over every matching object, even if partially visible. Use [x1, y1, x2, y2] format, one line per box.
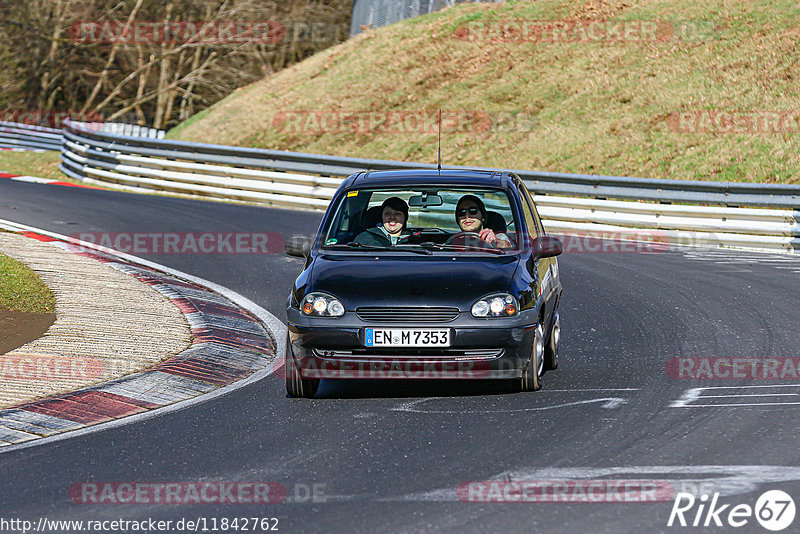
[286, 308, 537, 380]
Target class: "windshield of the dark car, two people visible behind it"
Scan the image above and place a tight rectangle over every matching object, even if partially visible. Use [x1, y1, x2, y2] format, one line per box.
[322, 187, 519, 254]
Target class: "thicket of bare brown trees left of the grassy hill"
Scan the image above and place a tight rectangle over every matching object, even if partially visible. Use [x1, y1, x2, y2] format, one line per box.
[0, 0, 352, 128]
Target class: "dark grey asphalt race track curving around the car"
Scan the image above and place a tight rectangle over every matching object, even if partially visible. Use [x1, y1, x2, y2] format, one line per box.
[0, 180, 800, 533]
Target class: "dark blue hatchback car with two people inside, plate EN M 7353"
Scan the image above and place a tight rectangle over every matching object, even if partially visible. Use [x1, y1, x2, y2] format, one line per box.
[285, 170, 562, 397]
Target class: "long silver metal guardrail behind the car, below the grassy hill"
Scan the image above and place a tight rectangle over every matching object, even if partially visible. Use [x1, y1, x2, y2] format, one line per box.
[53, 122, 800, 252]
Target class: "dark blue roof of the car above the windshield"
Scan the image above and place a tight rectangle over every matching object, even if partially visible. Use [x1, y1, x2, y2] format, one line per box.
[345, 169, 510, 189]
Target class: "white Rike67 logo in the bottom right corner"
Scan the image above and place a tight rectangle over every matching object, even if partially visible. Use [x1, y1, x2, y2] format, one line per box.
[667, 490, 796, 532]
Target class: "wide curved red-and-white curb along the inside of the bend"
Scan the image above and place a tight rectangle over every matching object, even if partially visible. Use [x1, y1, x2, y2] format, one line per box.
[0, 220, 285, 451]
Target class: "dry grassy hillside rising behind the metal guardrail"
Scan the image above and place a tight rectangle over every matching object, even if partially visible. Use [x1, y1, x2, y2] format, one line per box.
[169, 0, 800, 183]
